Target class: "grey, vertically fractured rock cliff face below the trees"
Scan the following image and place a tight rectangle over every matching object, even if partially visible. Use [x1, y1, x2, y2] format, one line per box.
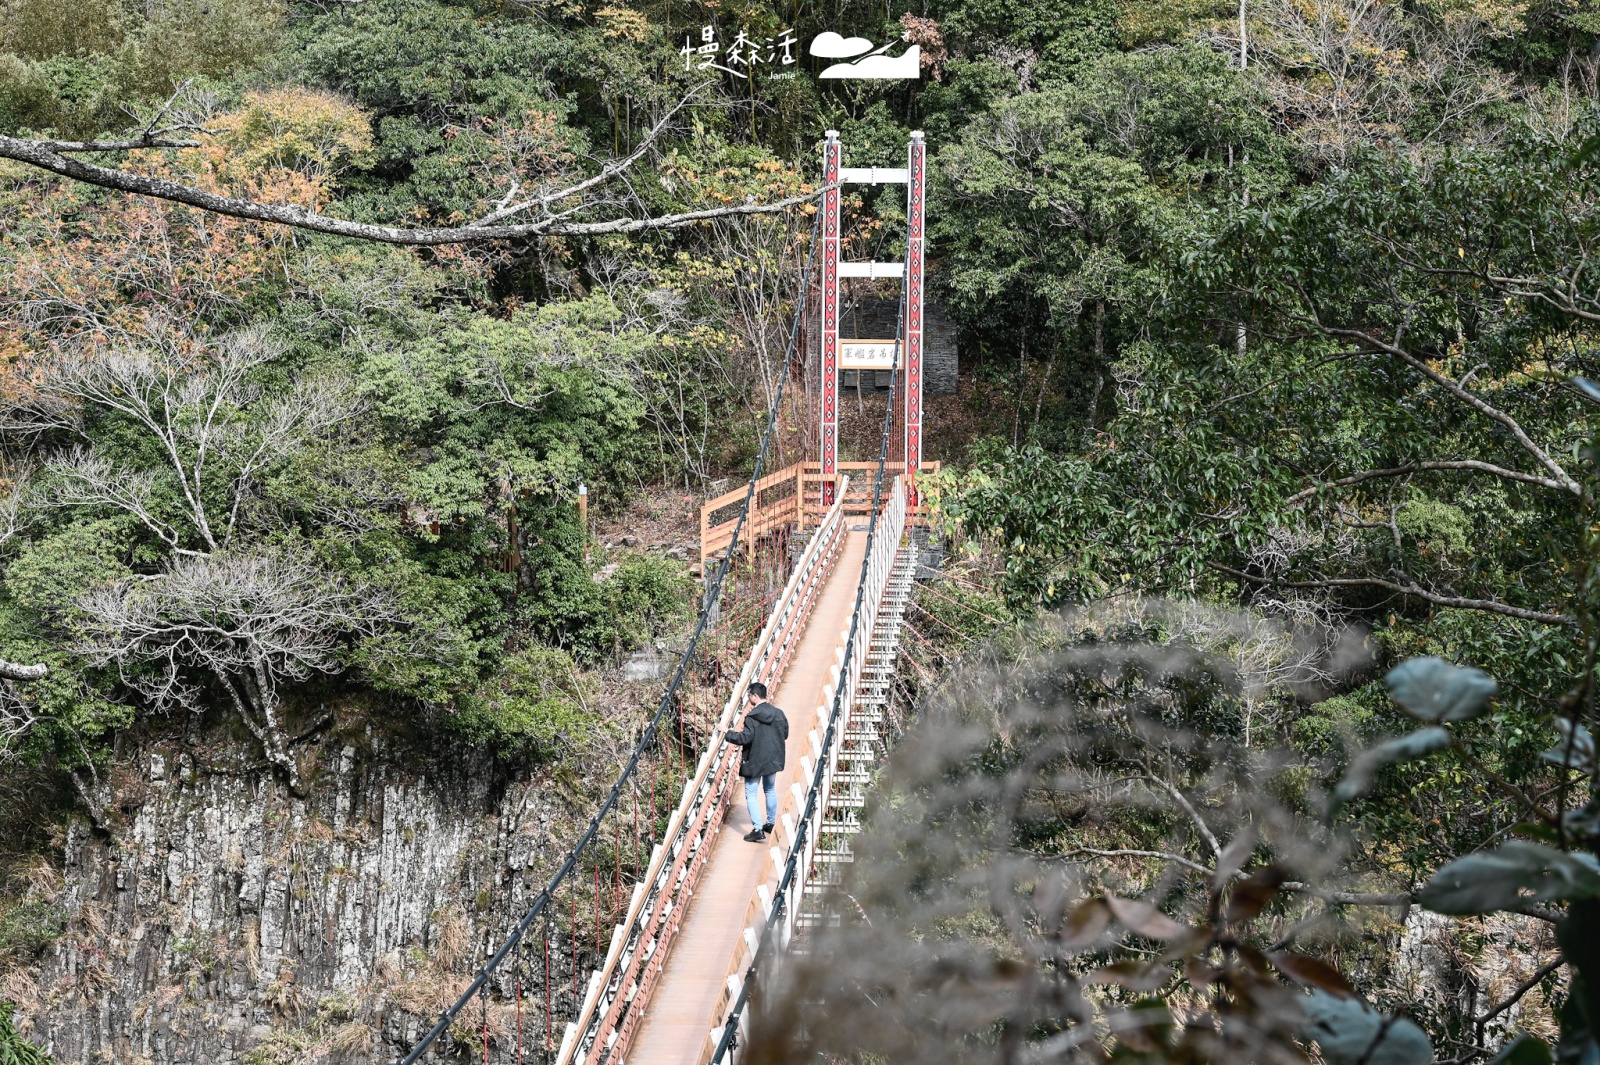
[5, 722, 582, 1063]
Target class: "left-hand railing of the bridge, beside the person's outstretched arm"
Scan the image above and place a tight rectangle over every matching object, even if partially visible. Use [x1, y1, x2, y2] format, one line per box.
[555, 478, 857, 1065]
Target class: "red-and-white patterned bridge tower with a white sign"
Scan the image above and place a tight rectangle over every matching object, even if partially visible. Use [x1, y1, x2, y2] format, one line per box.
[818, 130, 928, 507]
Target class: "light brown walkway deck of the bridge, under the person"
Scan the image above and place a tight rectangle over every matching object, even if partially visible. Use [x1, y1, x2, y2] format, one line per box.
[626, 531, 867, 1065]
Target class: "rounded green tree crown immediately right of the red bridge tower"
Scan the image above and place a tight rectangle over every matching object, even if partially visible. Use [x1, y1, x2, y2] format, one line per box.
[931, 46, 1285, 438]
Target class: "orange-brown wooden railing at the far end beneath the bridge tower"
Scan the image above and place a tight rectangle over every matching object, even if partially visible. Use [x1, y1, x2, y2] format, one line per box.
[701, 462, 942, 564]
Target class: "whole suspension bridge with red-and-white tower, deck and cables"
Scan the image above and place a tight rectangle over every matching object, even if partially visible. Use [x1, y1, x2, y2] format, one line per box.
[392, 131, 938, 1065]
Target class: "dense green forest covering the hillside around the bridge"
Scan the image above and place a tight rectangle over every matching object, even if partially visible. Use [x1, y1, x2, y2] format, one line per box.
[0, 0, 1600, 1065]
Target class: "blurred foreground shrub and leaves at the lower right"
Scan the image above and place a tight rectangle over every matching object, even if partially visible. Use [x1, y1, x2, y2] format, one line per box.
[752, 604, 1600, 1065]
